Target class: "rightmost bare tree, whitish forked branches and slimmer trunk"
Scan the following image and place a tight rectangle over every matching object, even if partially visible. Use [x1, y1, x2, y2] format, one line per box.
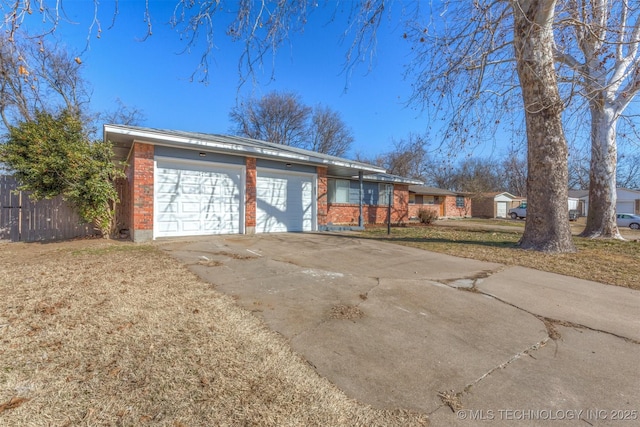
[555, 0, 640, 239]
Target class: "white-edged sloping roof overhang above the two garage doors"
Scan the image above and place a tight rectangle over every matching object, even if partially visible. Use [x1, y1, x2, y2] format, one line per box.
[103, 125, 385, 177]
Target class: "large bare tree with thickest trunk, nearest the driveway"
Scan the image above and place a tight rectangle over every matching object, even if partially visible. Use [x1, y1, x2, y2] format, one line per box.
[407, 0, 575, 252]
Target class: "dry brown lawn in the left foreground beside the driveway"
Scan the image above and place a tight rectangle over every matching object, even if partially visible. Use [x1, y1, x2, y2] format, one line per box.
[0, 240, 427, 427]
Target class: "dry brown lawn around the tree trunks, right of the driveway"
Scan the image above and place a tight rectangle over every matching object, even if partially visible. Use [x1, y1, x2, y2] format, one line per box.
[361, 219, 640, 290]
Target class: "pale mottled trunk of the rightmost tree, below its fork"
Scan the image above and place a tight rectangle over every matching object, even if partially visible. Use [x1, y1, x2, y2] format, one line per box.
[581, 95, 622, 239]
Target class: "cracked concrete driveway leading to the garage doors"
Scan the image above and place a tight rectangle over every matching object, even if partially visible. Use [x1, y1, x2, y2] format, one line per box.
[158, 233, 640, 426]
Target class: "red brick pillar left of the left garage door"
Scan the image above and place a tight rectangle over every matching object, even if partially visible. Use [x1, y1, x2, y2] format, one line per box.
[127, 143, 154, 242]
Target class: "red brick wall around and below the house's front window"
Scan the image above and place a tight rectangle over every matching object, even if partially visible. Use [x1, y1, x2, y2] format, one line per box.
[328, 184, 409, 225]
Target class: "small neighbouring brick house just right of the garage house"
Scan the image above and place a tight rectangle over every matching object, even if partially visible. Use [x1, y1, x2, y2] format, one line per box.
[409, 185, 471, 219]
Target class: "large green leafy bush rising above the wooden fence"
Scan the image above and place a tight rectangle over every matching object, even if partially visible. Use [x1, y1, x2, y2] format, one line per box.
[0, 110, 122, 237]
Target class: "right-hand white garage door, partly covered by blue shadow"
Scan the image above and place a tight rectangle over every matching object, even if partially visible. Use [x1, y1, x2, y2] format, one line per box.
[256, 169, 316, 233]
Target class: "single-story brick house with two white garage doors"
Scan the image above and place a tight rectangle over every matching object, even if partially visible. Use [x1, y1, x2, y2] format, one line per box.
[104, 125, 420, 242]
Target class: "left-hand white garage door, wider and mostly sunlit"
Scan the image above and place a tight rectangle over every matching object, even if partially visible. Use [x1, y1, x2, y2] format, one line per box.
[153, 158, 244, 238]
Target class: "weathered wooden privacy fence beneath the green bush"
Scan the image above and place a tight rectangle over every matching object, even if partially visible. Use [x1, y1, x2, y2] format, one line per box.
[0, 175, 96, 242]
